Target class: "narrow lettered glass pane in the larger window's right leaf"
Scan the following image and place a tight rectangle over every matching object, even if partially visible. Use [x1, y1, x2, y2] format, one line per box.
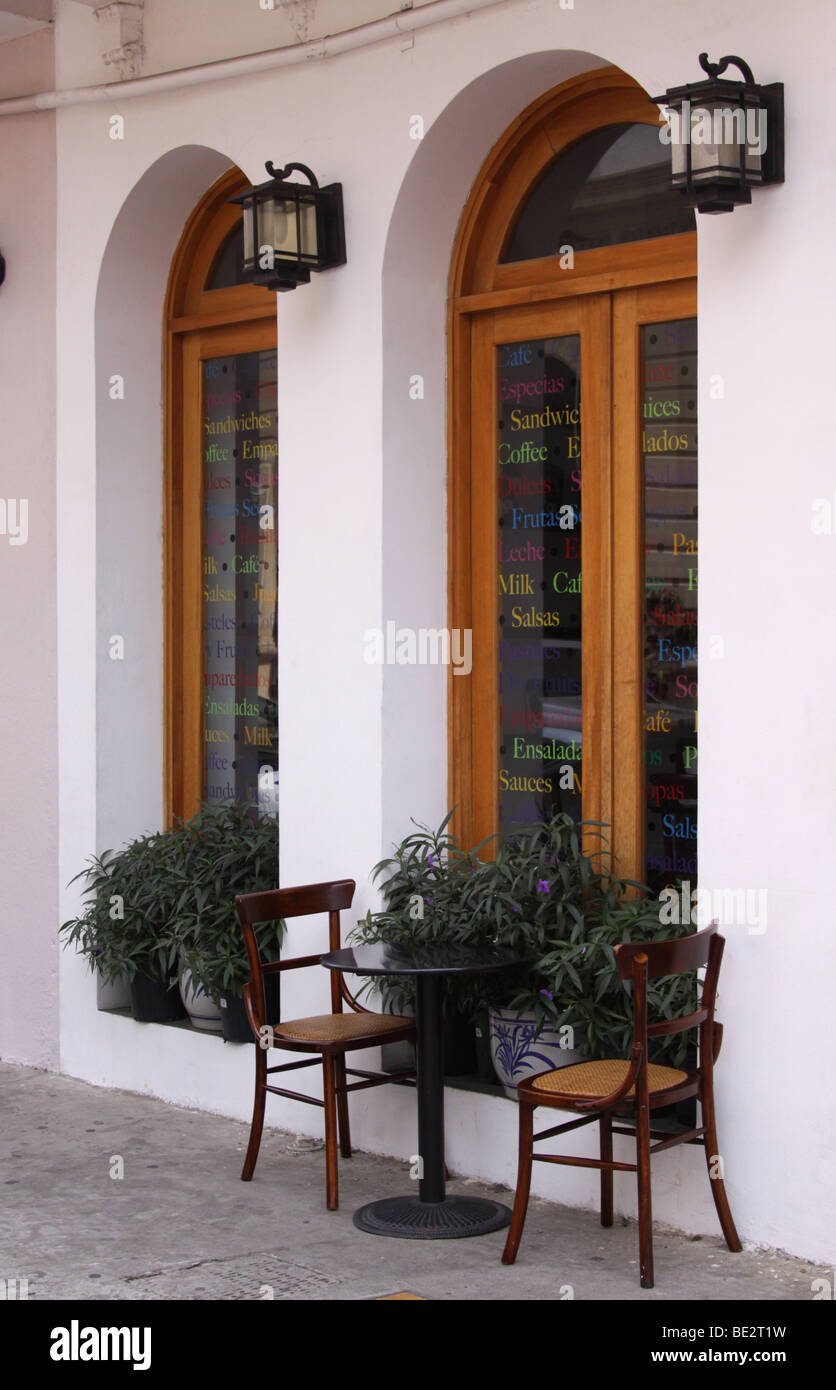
[641, 318, 697, 892]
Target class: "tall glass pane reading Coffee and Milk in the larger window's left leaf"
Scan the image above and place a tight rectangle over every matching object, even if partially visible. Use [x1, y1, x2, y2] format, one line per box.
[497, 335, 581, 840]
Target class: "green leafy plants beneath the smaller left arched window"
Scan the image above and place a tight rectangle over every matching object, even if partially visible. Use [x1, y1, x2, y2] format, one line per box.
[60, 803, 284, 1002]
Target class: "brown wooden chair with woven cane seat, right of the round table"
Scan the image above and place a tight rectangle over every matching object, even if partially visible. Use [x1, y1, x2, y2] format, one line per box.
[502, 922, 741, 1289]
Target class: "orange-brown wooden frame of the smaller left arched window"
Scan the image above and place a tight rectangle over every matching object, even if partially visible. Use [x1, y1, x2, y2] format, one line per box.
[163, 168, 275, 824]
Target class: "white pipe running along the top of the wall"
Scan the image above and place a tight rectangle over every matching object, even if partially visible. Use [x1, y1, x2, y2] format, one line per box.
[0, 0, 512, 115]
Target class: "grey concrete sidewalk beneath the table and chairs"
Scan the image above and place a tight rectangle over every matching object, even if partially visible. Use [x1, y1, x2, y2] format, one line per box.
[0, 1065, 828, 1301]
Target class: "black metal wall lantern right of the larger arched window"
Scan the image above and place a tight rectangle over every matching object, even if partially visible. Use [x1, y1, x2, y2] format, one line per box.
[651, 53, 783, 213]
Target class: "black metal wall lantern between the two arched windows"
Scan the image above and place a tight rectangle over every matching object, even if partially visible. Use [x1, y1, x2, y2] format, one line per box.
[230, 161, 345, 291]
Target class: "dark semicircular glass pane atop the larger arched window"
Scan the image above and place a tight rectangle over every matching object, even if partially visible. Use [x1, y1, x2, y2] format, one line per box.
[502, 124, 696, 261]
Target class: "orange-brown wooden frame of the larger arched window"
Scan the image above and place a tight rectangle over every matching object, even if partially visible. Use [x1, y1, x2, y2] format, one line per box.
[448, 67, 697, 878]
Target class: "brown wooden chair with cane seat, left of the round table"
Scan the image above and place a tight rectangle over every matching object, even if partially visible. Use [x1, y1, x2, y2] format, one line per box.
[235, 878, 415, 1211]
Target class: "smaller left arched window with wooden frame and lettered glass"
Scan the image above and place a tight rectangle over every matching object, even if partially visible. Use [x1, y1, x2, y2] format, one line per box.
[164, 170, 278, 819]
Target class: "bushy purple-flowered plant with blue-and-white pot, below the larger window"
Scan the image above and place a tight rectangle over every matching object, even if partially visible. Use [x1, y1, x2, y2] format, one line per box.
[357, 813, 693, 1094]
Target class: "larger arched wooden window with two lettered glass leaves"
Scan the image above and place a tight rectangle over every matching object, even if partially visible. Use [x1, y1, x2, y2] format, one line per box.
[448, 68, 697, 887]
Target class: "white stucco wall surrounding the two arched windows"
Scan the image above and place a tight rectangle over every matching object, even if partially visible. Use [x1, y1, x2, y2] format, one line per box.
[45, 0, 836, 1259]
